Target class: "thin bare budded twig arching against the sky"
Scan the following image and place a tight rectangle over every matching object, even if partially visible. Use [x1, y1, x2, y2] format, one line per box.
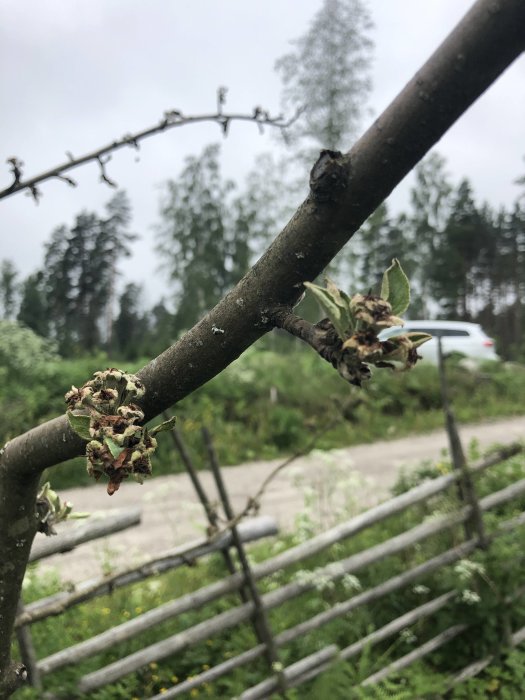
[0, 88, 299, 204]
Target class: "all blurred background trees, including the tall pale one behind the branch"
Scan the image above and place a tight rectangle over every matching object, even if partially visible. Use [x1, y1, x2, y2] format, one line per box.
[0, 0, 525, 360]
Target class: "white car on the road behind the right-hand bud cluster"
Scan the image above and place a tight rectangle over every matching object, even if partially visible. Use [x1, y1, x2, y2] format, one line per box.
[379, 321, 500, 364]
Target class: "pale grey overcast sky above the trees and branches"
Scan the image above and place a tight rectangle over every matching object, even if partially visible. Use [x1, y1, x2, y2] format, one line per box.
[0, 0, 525, 305]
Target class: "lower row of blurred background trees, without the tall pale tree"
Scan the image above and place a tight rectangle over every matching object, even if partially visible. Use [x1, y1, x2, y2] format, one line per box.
[0, 144, 525, 360]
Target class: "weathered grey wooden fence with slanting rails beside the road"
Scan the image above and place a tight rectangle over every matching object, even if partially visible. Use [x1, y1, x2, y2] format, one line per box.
[17, 434, 525, 700]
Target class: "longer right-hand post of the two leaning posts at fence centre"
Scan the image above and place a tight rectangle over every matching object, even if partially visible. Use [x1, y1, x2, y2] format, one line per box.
[202, 427, 286, 696]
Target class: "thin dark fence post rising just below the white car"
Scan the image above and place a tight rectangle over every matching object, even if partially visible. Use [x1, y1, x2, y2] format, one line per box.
[437, 335, 488, 549]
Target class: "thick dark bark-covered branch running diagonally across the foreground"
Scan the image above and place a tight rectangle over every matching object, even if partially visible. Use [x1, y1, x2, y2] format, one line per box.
[0, 0, 525, 697]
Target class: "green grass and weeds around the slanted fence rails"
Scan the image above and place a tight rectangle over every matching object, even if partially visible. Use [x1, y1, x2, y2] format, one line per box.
[15, 456, 525, 700]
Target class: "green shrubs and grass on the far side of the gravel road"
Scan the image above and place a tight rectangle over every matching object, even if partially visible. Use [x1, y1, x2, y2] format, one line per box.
[5, 347, 525, 489]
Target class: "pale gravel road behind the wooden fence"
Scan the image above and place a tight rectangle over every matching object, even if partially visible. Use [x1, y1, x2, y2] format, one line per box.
[41, 416, 525, 582]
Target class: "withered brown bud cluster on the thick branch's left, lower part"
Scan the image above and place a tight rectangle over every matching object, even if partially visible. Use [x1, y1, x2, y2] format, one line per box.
[65, 368, 175, 496]
